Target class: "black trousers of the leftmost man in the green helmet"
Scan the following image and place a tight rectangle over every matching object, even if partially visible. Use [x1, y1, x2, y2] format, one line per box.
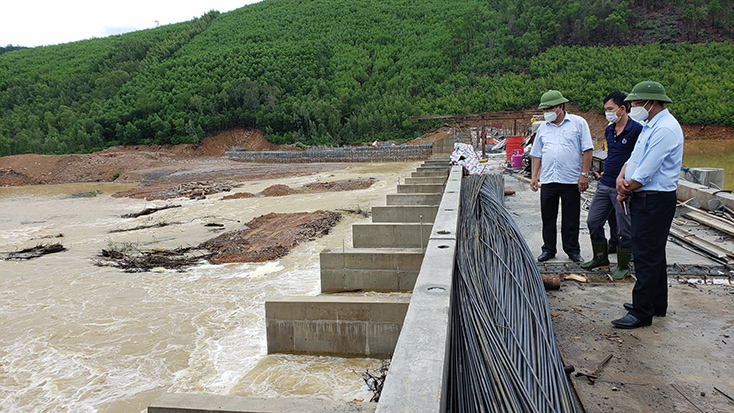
[540, 183, 581, 256]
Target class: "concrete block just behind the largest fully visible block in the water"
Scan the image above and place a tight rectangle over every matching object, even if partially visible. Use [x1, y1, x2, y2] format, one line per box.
[319, 248, 423, 293]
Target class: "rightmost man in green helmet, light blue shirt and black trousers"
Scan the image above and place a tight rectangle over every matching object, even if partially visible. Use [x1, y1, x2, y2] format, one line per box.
[612, 80, 683, 328]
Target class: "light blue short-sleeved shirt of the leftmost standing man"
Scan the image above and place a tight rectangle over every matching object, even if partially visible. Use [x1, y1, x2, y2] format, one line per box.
[530, 113, 594, 184]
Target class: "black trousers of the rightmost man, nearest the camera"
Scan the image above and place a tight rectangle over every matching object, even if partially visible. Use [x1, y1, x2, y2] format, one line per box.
[630, 191, 676, 321]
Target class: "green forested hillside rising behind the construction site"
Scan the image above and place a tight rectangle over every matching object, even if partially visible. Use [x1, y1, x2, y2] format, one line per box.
[0, 0, 734, 155]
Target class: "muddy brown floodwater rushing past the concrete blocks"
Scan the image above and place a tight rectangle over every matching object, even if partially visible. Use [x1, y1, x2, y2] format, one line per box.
[0, 162, 419, 412]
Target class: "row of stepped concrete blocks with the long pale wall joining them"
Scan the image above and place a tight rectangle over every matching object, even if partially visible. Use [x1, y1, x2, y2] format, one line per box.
[148, 156, 461, 413]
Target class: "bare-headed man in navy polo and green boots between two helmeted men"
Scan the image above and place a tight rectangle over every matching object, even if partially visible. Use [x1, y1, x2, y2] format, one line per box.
[580, 92, 642, 280]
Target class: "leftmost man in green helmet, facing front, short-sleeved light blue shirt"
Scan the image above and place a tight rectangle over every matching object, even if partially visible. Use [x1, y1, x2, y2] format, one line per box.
[530, 90, 594, 262]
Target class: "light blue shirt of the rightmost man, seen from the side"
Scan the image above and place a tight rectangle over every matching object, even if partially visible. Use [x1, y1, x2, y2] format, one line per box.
[624, 109, 683, 192]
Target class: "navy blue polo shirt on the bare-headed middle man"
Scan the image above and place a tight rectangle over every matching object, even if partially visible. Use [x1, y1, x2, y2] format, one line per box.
[599, 117, 642, 188]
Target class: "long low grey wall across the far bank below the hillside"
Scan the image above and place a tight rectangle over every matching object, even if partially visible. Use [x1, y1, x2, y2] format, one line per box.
[224, 144, 432, 163]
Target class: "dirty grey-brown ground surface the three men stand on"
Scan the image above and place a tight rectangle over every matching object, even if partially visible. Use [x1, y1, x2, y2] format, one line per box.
[505, 171, 734, 412]
